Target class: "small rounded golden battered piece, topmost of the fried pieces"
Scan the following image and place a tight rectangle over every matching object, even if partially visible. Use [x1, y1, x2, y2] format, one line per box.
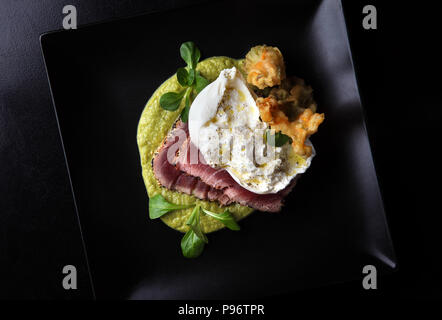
[245, 45, 285, 89]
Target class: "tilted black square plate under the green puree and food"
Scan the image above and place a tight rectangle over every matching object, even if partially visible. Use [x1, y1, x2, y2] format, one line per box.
[41, 0, 396, 299]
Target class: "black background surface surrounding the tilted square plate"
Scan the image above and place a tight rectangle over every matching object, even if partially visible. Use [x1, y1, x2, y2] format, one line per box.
[0, 0, 442, 299]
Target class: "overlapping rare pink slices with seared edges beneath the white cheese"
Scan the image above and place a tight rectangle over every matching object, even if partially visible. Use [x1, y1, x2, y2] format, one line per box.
[153, 121, 296, 212]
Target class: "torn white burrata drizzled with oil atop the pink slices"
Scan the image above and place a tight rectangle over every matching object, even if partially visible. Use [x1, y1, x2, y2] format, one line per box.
[189, 67, 315, 194]
